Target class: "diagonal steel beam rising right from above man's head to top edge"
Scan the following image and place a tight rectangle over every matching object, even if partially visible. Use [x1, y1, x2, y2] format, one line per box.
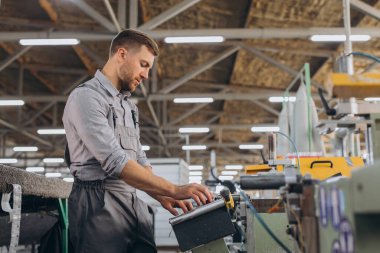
[138, 0, 200, 30]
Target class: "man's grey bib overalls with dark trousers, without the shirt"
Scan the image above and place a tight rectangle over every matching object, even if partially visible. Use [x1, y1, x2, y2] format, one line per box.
[65, 84, 157, 253]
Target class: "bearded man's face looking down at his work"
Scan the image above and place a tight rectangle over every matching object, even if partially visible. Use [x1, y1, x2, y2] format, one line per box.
[119, 45, 154, 92]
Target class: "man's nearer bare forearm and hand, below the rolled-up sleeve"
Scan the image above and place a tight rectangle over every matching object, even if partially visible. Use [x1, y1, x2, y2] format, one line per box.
[120, 160, 212, 205]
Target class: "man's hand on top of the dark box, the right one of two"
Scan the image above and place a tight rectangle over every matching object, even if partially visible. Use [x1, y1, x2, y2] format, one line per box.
[173, 184, 213, 206]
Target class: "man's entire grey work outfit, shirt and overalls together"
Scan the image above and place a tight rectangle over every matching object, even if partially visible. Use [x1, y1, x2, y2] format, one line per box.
[63, 71, 156, 253]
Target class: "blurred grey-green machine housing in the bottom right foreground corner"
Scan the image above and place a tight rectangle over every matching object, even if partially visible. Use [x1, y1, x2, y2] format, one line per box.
[315, 163, 380, 253]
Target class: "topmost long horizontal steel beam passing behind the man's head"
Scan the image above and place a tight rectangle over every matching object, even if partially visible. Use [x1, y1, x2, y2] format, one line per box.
[0, 27, 380, 41]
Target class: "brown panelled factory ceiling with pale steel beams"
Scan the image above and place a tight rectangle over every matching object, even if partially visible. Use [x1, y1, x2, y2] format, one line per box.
[0, 0, 380, 174]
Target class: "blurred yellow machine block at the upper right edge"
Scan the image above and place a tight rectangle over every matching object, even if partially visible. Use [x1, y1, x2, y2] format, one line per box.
[331, 73, 380, 98]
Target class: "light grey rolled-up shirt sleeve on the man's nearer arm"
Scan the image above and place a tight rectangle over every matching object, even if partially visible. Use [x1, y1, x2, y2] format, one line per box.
[68, 87, 130, 177]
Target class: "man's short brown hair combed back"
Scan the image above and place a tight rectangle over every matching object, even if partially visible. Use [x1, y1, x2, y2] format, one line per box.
[109, 29, 159, 57]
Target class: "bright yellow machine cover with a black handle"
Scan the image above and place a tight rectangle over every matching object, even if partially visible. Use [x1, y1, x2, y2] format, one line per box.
[277, 157, 364, 180]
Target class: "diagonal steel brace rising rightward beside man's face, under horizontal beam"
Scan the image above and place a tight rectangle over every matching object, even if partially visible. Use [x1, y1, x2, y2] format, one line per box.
[160, 46, 239, 94]
